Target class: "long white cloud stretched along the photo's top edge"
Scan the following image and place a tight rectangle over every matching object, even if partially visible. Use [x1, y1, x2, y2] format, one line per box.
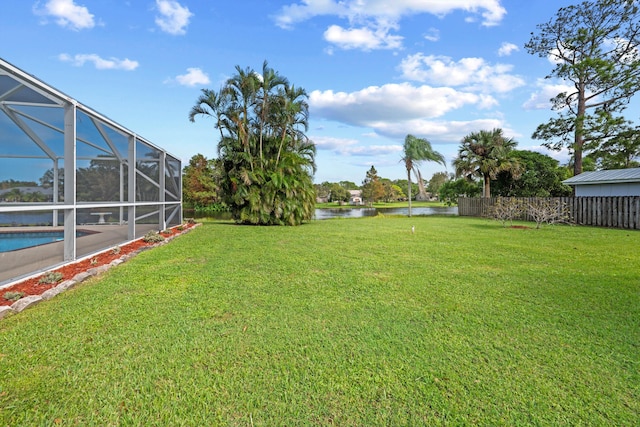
[275, 0, 507, 28]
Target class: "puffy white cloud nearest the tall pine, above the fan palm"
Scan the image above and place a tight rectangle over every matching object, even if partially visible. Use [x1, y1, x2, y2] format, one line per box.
[399, 53, 525, 93]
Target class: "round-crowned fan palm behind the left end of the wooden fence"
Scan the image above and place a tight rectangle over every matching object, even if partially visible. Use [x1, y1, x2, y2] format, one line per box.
[453, 128, 521, 197]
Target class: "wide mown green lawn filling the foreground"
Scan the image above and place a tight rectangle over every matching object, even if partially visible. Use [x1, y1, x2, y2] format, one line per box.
[0, 216, 640, 426]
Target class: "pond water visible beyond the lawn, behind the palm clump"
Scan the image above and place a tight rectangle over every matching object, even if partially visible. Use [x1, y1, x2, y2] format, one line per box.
[184, 206, 458, 219]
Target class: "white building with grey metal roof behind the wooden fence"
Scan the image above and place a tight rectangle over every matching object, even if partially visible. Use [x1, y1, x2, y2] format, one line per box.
[562, 168, 640, 197]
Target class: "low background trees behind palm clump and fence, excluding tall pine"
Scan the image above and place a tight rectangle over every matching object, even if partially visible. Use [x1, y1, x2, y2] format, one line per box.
[183, 129, 571, 211]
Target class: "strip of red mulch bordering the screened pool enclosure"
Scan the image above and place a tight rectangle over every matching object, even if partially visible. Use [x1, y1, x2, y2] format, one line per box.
[0, 224, 194, 306]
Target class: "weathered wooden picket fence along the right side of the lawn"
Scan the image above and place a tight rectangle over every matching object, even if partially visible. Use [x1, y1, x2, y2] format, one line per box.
[458, 196, 640, 230]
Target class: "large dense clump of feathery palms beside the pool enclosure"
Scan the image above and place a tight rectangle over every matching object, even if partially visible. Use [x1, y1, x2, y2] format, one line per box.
[189, 62, 316, 225]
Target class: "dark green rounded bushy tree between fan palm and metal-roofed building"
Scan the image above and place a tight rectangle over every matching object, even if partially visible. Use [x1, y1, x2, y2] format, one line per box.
[491, 150, 572, 197]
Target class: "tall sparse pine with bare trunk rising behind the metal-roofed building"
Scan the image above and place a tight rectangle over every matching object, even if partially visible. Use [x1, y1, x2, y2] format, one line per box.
[525, 0, 640, 175]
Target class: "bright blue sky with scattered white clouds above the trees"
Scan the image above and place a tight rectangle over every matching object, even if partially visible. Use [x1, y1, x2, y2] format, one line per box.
[0, 0, 638, 184]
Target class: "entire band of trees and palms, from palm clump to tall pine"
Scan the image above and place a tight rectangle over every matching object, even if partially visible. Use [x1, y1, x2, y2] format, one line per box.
[184, 0, 640, 225]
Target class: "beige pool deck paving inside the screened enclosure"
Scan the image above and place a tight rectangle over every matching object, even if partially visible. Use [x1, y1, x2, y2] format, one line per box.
[0, 224, 158, 289]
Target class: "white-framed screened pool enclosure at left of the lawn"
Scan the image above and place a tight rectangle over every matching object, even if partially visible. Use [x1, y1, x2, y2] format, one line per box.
[0, 59, 182, 285]
